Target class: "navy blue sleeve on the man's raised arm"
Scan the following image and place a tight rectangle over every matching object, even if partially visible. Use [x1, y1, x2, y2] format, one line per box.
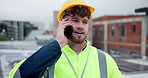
[19, 40, 62, 78]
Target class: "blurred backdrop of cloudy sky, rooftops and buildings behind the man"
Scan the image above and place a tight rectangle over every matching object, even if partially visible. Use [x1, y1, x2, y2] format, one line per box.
[0, 0, 148, 78]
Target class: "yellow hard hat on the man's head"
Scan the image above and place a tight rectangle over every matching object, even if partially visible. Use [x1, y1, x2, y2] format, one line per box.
[57, 0, 95, 22]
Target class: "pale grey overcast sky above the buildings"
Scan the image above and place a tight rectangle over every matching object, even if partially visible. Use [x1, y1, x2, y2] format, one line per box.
[0, 0, 148, 29]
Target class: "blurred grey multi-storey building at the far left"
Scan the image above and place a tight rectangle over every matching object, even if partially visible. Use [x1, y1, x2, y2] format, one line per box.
[0, 20, 38, 40]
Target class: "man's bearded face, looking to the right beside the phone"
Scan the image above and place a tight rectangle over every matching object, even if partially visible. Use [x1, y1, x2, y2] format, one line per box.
[69, 16, 89, 44]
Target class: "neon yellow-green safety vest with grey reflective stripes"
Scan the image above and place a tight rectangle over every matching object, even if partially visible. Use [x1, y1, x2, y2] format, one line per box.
[9, 41, 123, 78]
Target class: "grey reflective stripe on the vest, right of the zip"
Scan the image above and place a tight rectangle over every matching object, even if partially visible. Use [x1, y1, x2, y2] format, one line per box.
[97, 49, 107, 78]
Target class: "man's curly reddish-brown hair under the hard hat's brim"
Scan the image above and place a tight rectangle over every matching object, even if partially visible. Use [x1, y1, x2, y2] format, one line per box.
[61, 5, 91, 19]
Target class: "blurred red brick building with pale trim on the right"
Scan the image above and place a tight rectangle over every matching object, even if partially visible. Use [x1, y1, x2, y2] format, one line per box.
[93, 15, 148, 56]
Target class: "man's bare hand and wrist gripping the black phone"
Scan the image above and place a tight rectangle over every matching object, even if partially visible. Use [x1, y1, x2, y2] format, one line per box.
[56, 17, 72, 48]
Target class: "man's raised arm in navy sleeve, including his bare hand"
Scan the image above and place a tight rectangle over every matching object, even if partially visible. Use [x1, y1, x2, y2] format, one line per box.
[9, 17, 72, 78]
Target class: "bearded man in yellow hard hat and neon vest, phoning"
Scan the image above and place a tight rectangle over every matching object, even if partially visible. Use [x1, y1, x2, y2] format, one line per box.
[9, 0, 122, 78]
